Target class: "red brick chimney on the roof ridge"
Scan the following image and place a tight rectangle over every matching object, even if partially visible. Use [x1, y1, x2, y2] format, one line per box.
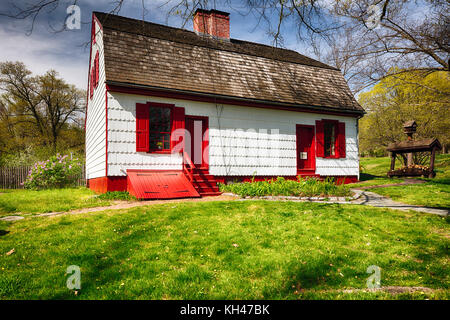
[194, 9, 230, 40]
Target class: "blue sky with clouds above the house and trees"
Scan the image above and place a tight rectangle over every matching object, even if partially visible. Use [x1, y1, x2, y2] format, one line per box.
[0, 0, 312, 89]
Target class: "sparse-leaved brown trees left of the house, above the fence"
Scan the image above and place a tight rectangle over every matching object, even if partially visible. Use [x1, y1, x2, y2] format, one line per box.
[0, 62, 85, 164]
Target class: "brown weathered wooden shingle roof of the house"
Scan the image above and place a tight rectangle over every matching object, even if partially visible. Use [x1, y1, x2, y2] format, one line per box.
[94, 12, 364, 113]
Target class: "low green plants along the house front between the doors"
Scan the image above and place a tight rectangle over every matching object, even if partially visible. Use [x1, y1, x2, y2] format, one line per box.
[220, 177, 351, 197]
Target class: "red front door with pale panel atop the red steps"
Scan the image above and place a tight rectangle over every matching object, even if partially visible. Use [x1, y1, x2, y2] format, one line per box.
[185, 116, 209, 168]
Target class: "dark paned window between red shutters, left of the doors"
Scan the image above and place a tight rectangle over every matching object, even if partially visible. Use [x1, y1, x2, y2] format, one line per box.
[149, 107, 171, 151]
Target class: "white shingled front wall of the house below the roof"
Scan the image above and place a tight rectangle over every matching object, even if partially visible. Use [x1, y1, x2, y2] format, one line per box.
[108, 92, 359, 176]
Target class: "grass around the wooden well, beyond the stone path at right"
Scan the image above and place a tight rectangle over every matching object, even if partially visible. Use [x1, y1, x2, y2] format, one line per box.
[349, 154, 450, 208]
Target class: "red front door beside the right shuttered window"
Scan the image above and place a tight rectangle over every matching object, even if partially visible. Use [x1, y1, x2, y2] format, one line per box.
[297, 124, 316, 174]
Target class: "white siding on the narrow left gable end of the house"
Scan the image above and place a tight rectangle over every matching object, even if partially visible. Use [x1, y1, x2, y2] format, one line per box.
[86, 23, 106, 179]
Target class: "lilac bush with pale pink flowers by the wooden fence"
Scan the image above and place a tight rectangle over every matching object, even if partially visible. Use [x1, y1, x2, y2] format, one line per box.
[24, 153, 81, 190]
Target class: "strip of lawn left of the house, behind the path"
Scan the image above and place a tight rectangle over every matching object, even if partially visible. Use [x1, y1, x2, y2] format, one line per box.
[0, 188, 110, 216]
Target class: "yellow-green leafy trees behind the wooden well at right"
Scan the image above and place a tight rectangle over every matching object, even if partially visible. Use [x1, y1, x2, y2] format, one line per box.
[358, 70, 450, 155]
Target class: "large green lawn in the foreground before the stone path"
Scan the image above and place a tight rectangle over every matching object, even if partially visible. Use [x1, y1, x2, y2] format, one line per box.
[0, 201, 450, 299]
